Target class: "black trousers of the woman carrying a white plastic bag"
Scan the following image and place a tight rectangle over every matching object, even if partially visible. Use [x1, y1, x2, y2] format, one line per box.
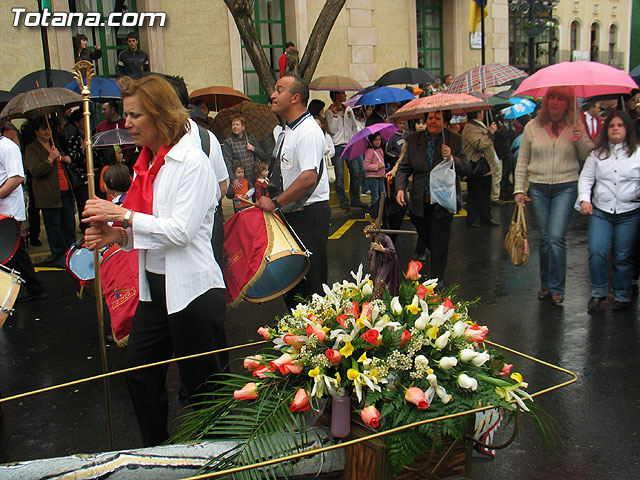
[411, 203, 452, 285]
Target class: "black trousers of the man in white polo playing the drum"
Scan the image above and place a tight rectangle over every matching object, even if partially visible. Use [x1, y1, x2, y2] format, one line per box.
[284, 201, 331, 308]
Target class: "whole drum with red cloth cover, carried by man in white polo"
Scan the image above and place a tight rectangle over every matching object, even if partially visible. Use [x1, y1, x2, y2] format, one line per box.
[222, 207, 310, 306]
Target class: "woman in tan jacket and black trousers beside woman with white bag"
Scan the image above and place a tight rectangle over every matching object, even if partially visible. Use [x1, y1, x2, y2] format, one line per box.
[462, 111, 500, 228]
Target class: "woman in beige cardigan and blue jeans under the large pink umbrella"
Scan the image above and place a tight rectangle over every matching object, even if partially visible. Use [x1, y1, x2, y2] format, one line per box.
[514, 87, 593, 305]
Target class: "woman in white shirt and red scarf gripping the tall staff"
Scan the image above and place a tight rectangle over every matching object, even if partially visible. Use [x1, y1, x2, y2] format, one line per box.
[83, 75, 228, 446]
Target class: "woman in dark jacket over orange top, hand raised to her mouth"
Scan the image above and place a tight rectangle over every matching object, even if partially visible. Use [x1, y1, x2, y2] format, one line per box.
[24, 117, 76, 268]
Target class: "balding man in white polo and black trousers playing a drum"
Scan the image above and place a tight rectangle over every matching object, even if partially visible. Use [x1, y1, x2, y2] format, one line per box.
[256, 76, 331, 308]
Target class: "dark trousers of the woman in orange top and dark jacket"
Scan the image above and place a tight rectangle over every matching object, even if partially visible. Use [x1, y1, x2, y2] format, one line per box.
[41, 190, 76, 267]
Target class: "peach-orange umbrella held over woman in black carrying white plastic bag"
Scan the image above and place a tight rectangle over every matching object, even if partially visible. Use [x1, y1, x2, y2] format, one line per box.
[390, 93, 491, 120]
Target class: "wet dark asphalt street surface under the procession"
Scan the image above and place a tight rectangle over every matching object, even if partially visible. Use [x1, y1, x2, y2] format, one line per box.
[0, 204, 640, 480]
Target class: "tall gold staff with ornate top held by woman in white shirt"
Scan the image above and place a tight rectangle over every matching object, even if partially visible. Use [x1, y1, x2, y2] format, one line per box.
[73, 60, 115, 450]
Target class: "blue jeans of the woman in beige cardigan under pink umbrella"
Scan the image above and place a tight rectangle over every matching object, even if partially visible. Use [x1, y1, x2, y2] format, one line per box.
[529, 182, 578, 295]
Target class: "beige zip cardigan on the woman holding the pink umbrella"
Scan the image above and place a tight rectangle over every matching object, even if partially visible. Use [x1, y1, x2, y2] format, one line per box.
[514, 119, 593, 193]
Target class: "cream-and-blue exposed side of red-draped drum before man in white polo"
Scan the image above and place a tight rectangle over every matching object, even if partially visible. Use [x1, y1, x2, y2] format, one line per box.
[245, 213, 309, 302]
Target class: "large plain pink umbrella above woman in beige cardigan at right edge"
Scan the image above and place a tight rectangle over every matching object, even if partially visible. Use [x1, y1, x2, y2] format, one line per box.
[513, 62, 638, 98]
